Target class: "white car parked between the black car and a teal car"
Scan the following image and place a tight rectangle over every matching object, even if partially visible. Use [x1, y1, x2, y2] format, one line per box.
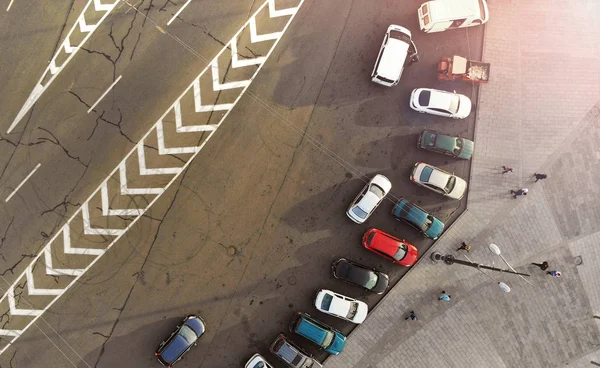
[315, 289, 369, 324]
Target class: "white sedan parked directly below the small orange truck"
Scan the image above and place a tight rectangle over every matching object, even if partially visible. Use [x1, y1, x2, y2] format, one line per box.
[410, 88, 471, 119]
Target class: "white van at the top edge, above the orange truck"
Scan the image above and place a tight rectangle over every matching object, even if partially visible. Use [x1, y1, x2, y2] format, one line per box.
[419, 0, 490, 33]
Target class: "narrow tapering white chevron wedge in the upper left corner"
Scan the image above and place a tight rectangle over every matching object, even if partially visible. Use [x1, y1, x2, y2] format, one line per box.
[6, 0, 120, 133]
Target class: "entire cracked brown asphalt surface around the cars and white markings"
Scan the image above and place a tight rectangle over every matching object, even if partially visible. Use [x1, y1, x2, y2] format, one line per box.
[0, 0, 482, 368]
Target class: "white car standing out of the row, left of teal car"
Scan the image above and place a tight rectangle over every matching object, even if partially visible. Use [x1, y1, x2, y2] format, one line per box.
[346, 174, 392, 224]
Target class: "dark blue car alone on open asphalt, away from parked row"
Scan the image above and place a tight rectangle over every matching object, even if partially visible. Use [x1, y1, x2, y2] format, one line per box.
[156, 315, 206, 367]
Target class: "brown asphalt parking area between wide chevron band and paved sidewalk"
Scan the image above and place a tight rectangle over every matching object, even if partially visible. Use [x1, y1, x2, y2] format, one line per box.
[0, 0, 482, 368]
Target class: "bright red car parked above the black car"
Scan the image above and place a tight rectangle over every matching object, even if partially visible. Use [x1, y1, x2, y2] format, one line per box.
[363, 229, 419, 267]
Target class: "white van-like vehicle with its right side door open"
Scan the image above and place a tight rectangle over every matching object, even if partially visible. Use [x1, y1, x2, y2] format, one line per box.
[371, 24, 419, 87]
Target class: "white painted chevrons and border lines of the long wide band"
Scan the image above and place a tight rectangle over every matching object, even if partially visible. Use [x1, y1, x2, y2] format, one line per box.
[0, 0, 304, 354]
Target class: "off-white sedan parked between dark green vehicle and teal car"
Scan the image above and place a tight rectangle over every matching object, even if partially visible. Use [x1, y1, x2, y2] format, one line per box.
[410, 162, 467, 199]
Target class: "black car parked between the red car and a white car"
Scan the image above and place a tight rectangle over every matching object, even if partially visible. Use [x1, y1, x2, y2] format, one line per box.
[331, 258, 390, 294]
